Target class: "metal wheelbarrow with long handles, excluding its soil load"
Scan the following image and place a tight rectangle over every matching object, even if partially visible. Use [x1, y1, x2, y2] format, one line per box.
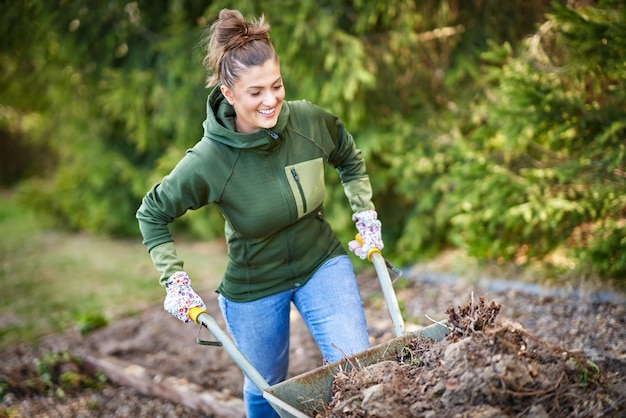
[190, 252, 449, 418]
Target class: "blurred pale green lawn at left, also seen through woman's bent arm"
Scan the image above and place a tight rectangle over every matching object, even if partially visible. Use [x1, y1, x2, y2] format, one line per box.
[0, 192, 226, 348]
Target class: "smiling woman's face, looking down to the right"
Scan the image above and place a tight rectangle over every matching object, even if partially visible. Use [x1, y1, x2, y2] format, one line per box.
[221, 59, 285, 133]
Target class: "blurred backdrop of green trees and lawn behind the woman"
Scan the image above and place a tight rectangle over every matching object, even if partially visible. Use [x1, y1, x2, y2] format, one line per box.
[0, 0, 626, 343]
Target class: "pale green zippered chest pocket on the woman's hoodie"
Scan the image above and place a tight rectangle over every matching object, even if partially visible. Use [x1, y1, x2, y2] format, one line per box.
[285, 158, 326, 219]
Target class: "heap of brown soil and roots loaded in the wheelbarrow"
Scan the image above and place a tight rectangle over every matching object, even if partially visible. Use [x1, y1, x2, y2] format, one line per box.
[318, 297, 626, 418]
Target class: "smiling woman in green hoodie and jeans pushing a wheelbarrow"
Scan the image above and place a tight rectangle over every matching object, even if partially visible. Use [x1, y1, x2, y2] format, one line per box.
[137, 9, 383, 417]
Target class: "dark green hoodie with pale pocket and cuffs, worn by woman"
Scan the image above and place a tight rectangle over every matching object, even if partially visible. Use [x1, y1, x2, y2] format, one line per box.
[137, 87, 374, 302]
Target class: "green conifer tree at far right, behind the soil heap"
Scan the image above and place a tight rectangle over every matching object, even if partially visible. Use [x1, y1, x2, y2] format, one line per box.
[442, 2, 626, 278]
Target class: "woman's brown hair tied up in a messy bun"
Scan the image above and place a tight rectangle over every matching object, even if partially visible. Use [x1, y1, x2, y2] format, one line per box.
[201, 9, 278, 88]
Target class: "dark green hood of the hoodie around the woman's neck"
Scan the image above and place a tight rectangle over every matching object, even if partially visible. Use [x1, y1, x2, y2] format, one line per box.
[202, 85, 289, 151]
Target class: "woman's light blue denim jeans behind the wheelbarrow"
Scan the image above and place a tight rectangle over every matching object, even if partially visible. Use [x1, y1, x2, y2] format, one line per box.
[219, 255, 369, 418]
